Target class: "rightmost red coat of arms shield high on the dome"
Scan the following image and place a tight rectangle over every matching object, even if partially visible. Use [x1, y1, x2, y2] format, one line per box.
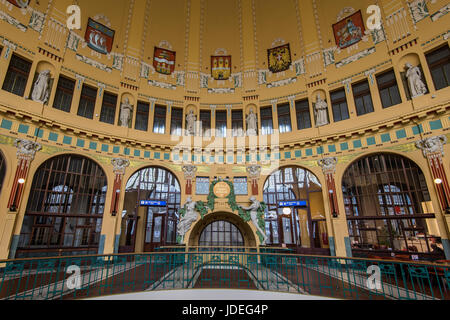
[333, 10, 365, 49]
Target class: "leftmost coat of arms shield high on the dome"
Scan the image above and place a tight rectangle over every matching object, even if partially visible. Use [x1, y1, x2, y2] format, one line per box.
[84, 18, 115, 54]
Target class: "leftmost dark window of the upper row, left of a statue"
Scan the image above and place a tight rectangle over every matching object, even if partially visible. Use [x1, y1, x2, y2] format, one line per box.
[3, 54, 31, 97]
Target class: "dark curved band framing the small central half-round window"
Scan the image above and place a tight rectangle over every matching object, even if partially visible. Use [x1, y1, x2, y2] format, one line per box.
[188, 212, 256, 247]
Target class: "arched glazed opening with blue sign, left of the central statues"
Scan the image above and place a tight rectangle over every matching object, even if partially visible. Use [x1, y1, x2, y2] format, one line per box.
[119, 167, 181, 252]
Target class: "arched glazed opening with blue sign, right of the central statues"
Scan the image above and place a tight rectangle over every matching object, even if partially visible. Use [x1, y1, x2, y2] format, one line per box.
[263, 166, 328, 253]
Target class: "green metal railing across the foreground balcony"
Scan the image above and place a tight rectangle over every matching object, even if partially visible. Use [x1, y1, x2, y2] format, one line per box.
[0, 247, 450, 300]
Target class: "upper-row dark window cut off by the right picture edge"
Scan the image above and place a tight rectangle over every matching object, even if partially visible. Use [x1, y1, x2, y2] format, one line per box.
[426, 45, 450, 90]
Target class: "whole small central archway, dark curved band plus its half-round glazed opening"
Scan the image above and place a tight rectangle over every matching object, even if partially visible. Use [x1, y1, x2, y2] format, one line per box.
[188, 212, 256, 247]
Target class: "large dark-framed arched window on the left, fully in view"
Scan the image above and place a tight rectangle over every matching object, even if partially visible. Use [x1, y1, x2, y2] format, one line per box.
[16, 155, 107, 257]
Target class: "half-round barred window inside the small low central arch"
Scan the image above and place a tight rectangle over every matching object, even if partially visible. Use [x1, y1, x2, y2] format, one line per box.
[198, 220, 244, 247]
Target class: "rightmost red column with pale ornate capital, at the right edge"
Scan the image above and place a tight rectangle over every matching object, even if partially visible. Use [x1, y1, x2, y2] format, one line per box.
[416, 135, 450, 259]
